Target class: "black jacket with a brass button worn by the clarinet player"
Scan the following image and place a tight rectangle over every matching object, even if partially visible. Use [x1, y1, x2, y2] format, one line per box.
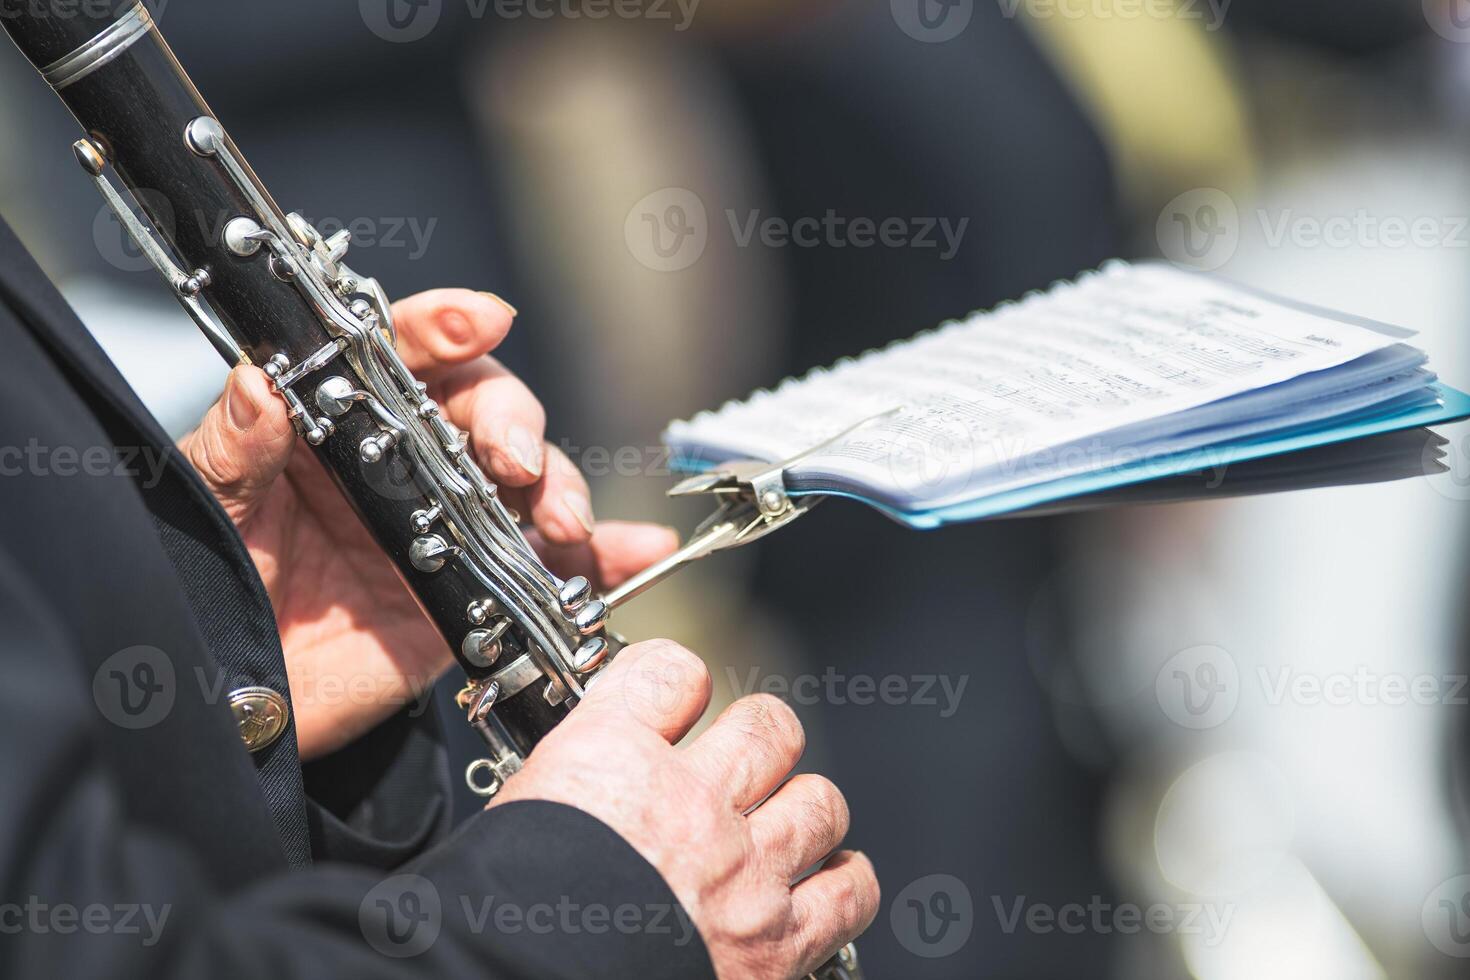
[0, 223, 711, 979]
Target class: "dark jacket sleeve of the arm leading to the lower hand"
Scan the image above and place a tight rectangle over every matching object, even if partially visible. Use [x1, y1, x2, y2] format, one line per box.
[0, 552, 711, 980]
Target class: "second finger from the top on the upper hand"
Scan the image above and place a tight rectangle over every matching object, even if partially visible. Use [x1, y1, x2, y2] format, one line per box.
[442, 357, 547, 486]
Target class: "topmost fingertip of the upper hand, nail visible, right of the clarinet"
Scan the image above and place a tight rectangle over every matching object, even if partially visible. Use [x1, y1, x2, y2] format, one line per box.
[392, 289, 515, 379]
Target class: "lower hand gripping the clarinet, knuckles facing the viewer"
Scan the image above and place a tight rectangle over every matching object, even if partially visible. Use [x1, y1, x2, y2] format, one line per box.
[491, 641, 878, 979]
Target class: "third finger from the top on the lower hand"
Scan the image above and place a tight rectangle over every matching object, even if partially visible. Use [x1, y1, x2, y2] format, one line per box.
[750, 773, 851, 880]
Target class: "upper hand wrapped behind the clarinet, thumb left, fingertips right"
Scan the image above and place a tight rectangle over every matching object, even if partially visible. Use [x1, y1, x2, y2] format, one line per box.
[181, 289, 678, 758]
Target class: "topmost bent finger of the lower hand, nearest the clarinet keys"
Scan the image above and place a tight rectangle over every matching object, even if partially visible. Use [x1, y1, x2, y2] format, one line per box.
[569, 639, 713, 742]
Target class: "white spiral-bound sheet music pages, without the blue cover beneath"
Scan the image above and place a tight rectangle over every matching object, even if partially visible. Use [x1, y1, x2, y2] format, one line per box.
[664, 263, 1405, 507]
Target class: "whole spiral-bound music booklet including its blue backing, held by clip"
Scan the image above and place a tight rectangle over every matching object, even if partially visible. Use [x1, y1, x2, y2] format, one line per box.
[664, 263, 1470, 527]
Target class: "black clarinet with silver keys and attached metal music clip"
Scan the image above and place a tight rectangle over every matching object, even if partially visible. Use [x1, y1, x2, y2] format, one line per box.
[0, 0, 861, 980]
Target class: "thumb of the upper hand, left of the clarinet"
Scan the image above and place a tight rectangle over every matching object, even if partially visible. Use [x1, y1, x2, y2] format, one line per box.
[181, 364, 295, 526]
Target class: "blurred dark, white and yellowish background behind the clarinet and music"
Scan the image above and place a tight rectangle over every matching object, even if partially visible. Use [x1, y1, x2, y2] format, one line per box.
[0, 0, 1470, 980]
